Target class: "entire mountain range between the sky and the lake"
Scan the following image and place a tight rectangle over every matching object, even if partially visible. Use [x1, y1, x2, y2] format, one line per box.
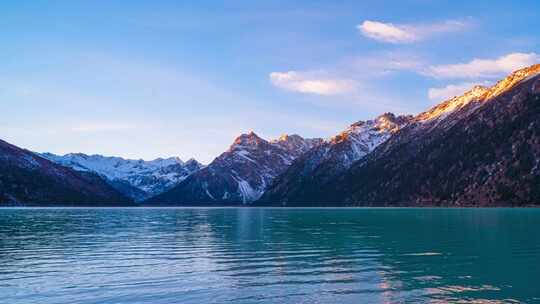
[0, 65, 540, 206]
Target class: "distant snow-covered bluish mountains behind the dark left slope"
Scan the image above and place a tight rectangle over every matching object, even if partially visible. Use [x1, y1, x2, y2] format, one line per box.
[41, 153, 203, 201]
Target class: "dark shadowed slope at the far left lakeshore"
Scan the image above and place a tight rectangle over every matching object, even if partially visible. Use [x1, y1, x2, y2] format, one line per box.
[0, 140, 130, 206]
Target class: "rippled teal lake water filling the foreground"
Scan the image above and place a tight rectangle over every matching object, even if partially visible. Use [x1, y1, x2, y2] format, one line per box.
[0, 208, 540, 304]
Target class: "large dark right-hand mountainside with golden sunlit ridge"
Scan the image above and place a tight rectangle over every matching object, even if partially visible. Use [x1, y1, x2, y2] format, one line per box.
[301, 65, 540, 206]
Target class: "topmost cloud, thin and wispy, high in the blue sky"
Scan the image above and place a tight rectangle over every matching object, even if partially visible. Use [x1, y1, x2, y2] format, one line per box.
[357, 20, 468, 44]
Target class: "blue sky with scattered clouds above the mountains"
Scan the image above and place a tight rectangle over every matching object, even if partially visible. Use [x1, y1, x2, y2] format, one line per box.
[0, 0, 540, 162]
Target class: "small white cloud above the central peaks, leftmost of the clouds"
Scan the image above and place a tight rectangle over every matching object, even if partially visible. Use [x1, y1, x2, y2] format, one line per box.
[270, 71, 355, 95]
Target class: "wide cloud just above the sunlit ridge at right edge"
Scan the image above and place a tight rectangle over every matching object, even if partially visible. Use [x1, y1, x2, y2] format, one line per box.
[423, 53, 540, 78]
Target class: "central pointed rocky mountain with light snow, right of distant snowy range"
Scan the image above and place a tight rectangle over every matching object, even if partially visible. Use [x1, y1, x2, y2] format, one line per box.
[149, 132, 322, 204]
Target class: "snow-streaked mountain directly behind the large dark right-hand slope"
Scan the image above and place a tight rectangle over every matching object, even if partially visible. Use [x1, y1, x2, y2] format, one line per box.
[260, 113, 412, 203]
